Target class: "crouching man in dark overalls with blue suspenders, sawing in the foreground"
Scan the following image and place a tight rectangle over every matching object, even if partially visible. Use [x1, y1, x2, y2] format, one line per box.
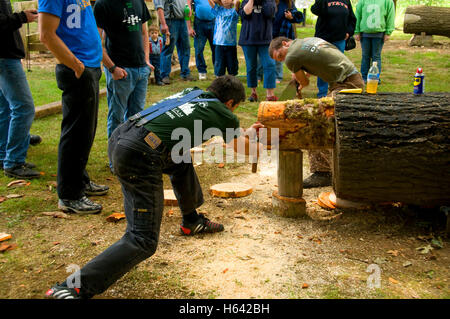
[46, 75, 262, 299]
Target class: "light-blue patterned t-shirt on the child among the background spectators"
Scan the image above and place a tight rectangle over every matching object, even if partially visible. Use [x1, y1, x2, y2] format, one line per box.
[212, 4, 239, 46]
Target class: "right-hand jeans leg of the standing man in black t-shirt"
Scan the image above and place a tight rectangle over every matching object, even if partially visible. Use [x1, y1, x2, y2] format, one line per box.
[124, 65, 150, 121]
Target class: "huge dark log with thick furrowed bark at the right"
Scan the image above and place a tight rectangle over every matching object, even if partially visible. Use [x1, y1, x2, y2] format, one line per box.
[333, 93, 450, 205]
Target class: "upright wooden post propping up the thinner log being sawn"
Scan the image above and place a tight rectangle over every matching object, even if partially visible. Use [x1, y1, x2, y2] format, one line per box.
[272, 150, 306, 217]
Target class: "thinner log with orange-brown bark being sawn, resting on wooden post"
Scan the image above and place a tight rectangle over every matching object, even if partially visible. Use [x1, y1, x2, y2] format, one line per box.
[258, 98, 335, 150]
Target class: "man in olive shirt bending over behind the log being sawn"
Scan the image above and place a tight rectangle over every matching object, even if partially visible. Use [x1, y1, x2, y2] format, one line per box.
[269, 37, 364, 188]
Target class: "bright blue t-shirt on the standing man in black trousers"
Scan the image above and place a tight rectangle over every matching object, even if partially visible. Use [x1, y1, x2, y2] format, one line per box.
[39, 0, 103, 68]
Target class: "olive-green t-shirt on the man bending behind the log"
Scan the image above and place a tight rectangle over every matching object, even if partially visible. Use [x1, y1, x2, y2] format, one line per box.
[286, 38, 358, 84]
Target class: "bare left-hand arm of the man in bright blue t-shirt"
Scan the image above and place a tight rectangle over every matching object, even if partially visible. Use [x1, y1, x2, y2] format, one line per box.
[39, 12, 84, 79]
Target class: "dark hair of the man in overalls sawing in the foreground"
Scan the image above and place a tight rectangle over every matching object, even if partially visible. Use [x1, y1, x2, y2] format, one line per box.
[206, 74, 245, 105]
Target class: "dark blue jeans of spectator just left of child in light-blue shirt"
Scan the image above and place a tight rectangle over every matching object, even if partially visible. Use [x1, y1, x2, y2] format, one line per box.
[194, 17, 215, 73]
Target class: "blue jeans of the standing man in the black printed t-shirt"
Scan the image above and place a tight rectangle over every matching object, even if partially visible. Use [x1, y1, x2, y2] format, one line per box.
[105, 66, 150, 138]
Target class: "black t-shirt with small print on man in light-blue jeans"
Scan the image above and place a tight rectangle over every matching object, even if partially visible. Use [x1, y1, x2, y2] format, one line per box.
[94, 0, 150, 67]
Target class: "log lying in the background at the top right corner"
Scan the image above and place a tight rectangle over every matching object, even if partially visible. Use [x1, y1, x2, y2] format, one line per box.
[403, 6, 450, 37]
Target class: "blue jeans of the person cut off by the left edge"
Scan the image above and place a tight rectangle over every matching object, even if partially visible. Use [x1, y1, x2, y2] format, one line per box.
[0, 59, 34, 168]
